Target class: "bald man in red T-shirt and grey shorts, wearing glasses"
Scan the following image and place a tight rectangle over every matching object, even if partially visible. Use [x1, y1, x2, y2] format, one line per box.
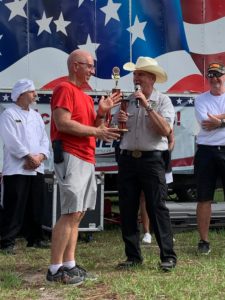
[47, 50, 121, 285]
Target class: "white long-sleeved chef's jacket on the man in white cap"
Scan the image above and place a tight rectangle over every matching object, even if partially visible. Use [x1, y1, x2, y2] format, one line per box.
[0, 104, 49, 175]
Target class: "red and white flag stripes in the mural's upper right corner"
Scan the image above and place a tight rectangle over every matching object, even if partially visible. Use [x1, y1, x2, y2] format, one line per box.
[181, 0, 225, 75]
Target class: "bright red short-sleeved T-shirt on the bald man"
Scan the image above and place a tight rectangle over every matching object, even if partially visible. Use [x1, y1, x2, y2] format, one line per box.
[51, 82, 96, 164]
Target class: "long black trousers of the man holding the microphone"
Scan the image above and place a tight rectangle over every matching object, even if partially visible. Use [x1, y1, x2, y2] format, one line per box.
[118, 151, 176, 261]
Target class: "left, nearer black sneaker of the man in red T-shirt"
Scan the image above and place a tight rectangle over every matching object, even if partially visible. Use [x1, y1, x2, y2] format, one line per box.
[46, 267, 84, 286]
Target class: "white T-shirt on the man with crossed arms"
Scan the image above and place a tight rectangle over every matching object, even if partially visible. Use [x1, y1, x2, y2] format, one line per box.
[195, 91, 225, 146]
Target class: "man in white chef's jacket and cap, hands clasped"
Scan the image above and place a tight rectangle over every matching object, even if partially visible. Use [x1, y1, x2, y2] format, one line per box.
[0, 79, 49, 253]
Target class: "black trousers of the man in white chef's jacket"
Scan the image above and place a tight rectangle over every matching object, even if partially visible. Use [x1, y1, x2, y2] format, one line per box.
[0, 173, 44, 248]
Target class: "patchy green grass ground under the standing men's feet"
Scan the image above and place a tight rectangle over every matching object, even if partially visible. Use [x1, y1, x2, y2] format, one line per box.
[0, 226, 225, 300]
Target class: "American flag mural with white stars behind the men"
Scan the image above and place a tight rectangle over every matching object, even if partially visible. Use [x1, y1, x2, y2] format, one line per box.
[0, 0, 225, 92]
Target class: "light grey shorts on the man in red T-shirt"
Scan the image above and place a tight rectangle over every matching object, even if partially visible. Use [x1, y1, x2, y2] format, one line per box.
[54, 152, 97, 215]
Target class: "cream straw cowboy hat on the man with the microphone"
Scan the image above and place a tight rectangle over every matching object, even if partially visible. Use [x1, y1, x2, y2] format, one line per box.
[123, 56, 167, 83]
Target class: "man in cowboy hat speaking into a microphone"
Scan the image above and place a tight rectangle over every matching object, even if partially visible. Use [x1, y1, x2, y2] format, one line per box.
[115, 57, 177, 271]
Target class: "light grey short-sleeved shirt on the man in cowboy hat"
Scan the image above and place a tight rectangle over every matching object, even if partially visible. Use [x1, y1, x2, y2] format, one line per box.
[114, 89, 175, 151]
